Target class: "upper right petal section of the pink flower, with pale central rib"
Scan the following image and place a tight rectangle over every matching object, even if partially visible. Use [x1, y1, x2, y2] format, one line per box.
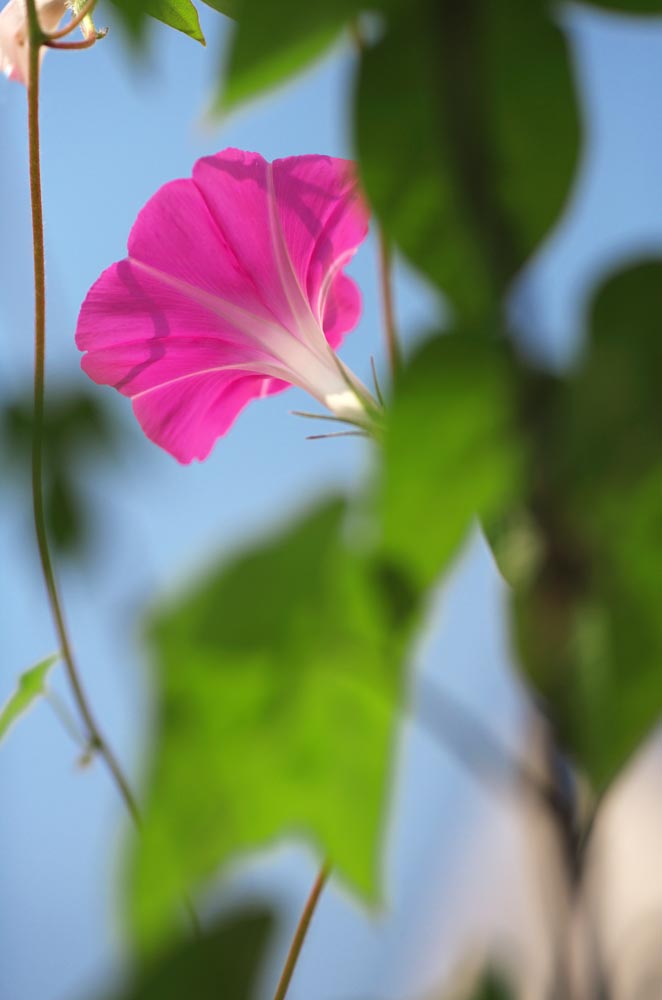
[193, 149, 368, 352]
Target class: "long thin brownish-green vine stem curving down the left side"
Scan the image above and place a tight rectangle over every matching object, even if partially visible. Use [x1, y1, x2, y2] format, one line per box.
[27, 0, 140, 826]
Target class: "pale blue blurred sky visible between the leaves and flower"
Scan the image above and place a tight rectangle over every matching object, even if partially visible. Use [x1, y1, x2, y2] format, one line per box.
[0, 4, 662, 1000]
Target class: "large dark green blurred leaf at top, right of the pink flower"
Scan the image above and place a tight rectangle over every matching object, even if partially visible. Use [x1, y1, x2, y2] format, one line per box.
[356, 0, 579, 319]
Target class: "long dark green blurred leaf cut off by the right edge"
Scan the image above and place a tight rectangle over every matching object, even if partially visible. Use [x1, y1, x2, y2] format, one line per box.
[519, 263, 662, 786]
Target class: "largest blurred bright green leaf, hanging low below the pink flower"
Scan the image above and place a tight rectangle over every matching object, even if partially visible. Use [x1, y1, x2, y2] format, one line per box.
[135, 503, 406, 942]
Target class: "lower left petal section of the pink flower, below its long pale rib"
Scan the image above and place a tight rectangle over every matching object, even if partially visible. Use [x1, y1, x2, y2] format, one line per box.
[76, 260, 289, 462]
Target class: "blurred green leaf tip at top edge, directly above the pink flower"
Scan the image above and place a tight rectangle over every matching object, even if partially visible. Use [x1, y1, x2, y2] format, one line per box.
[217, 0, 360, 111]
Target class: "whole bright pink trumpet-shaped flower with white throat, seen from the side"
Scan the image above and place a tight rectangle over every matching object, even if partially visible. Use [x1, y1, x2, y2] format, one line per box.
[76, 149, 377, 462]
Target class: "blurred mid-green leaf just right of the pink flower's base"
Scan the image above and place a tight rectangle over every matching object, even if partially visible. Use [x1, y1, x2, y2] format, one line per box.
[383, 333, 522, 585]
